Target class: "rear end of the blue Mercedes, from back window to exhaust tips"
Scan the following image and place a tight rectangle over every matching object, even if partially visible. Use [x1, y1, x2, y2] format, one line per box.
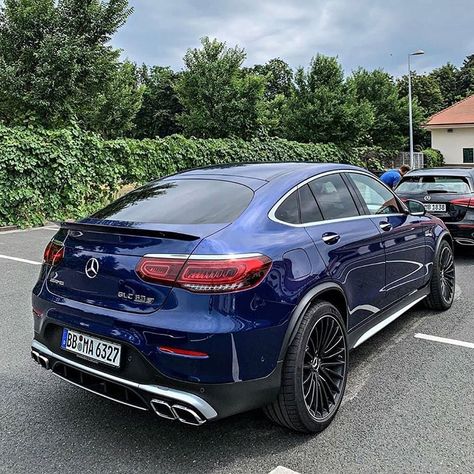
[32, 179, 290, 425]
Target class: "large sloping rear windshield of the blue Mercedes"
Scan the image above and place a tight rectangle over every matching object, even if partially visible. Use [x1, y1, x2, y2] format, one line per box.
[92, 179, 253, 224]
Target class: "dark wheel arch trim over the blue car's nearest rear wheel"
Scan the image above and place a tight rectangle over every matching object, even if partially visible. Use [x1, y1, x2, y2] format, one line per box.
[278, 282, 349, 361]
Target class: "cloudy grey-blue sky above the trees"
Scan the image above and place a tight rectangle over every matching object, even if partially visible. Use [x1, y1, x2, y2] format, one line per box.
[113, 0, 474, 76]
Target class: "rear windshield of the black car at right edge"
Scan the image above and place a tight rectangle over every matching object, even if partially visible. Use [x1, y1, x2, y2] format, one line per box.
[397, 176, 471, 194]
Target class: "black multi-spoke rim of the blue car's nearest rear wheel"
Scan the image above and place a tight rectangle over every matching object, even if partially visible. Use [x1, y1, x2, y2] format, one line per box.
[303, 314, 347, 421]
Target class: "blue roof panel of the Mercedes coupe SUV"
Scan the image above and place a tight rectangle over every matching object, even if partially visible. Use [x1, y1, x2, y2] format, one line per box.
[175, 162, 358, 181]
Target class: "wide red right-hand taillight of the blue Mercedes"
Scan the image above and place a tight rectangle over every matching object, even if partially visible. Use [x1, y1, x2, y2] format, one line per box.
[136, 255, 272, 293]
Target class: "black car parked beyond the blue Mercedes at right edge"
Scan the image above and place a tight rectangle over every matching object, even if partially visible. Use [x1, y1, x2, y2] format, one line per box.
[396, 168, 474, 246]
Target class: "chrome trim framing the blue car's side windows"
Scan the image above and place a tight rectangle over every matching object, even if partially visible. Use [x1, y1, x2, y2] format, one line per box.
[268, 170, 407, 227]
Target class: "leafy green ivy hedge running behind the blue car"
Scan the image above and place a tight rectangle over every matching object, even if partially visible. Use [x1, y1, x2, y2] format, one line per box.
[0, 125, 386, 227]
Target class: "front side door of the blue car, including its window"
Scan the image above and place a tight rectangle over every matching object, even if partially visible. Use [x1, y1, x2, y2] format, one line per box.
[346, 172, 429, 304]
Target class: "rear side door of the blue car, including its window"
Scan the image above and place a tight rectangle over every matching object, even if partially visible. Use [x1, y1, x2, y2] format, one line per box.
[300, 173, 385, 328]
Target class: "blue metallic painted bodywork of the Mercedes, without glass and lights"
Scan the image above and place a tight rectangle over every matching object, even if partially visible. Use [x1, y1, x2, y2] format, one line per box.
[33, 163, 445, 398]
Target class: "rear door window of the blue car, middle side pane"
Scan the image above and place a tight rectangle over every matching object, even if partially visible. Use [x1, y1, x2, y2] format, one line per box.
[309, 174, 359, 220]
